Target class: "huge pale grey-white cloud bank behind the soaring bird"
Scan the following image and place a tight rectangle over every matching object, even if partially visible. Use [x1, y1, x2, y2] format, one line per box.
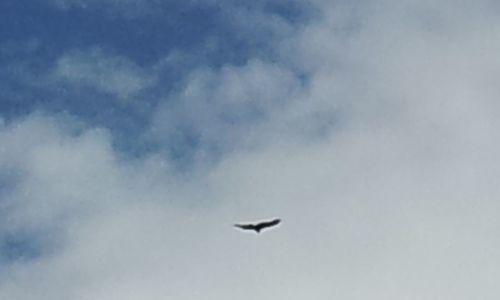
[0, 1, 500, 300]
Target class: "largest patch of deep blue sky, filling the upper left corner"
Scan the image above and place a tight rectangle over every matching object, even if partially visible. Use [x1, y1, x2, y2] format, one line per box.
[0, 1, 310, 159]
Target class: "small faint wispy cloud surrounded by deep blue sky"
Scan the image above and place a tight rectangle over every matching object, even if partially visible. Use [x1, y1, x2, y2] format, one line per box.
[51, 47, 155, 99]
